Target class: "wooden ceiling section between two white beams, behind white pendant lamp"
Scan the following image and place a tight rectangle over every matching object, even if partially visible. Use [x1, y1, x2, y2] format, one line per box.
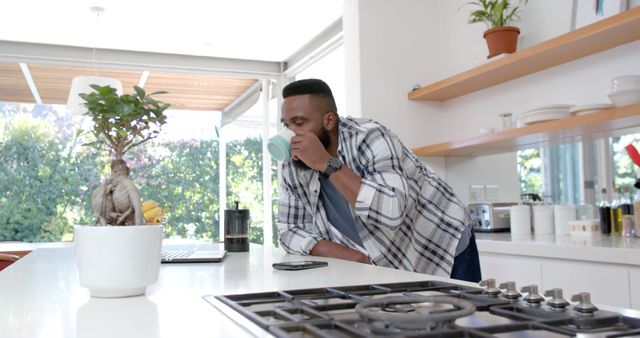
[29, 64, 142, 104]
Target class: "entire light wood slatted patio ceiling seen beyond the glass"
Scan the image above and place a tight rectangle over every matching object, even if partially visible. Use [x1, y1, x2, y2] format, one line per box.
[0, 63, 258, 111]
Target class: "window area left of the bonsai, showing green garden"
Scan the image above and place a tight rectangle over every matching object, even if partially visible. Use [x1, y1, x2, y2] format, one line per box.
[0, 104, 92, 242]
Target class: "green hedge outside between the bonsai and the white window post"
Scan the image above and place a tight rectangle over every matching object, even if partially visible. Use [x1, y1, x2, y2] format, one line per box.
[125, 140, 219, 240]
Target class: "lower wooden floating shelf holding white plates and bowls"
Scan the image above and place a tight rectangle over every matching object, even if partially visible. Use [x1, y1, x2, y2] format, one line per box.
[413, 104, 640, 157]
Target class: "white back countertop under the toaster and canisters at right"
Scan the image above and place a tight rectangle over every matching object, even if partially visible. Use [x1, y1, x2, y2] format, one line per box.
[476, 233, 640, 266]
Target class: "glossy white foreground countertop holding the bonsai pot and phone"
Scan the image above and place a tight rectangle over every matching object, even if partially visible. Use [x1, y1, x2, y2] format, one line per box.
[0, 243, 458, 338]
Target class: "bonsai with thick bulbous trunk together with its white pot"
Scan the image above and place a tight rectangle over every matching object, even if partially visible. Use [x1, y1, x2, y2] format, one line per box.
[74, 84, 170, 297]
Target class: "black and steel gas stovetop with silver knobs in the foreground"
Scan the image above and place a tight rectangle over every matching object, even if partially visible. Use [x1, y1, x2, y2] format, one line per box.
[204, 280, 640, 338]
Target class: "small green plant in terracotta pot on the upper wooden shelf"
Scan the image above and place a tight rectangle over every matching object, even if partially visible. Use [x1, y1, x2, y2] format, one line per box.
[465, 0, 528, 58]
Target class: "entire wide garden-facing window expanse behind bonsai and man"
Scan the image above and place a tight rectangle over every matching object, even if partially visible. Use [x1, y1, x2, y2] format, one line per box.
[0, 31, 348, 246]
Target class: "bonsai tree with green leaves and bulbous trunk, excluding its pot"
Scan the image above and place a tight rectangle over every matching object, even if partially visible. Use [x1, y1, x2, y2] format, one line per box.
[80, 85, 171, 225]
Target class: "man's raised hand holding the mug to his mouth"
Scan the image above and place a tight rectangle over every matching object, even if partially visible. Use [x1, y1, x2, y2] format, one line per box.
[291, 131, 331, 172]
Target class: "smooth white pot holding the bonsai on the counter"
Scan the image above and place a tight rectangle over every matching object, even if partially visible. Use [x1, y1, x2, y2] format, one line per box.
[73, 225, 164, 298]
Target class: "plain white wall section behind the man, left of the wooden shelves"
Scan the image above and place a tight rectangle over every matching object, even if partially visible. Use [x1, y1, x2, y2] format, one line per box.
[343, 0, 443, 147]
